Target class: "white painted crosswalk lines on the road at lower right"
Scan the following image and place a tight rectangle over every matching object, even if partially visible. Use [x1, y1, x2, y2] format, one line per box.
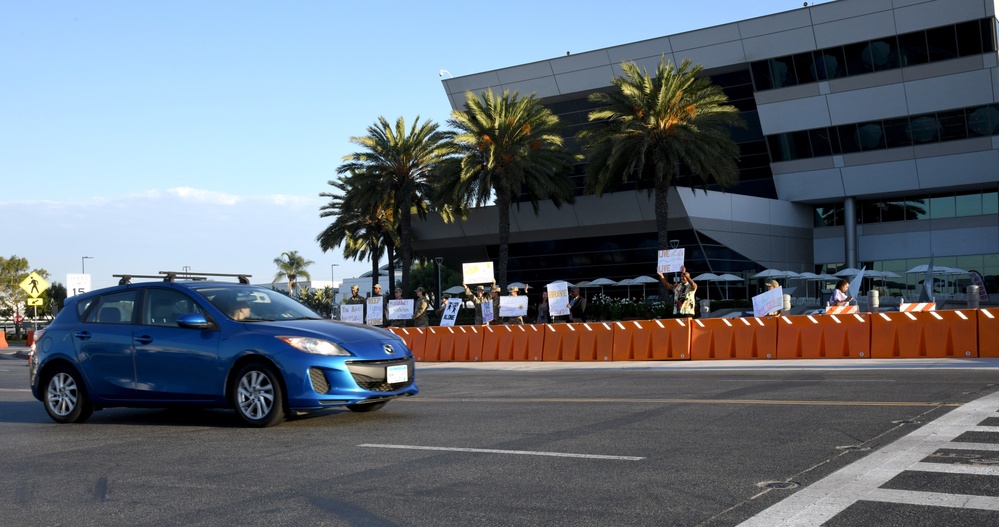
[740, 392, 999, 527]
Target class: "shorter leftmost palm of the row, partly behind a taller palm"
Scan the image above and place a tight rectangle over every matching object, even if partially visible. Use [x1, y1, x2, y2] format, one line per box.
[316, 174, 398, 289]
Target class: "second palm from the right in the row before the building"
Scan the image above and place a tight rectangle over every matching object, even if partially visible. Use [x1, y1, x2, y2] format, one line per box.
[446, 90, 577, 286]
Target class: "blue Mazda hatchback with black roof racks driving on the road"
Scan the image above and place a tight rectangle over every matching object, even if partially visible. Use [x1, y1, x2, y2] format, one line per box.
[30, 273, 419, 427]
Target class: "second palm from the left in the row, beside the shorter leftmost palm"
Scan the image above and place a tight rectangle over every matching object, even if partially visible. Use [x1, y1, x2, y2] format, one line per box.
[337, 116, 452, 291]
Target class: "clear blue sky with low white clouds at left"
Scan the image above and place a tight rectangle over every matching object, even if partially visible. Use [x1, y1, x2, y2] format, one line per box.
[0, 0, 821, 288]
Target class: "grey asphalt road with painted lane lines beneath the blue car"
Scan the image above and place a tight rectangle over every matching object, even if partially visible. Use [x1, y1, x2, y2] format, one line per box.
[0, 355, 999, 527]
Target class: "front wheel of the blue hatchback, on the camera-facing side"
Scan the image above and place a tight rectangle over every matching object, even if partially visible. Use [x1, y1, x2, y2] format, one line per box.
[229, 362, 285, 428]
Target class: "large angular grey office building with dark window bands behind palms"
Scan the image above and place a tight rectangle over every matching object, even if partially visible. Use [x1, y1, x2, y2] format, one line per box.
[415, 0, 999, 298]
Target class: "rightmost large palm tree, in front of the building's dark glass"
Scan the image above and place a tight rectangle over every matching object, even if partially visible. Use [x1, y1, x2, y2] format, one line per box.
[580, 55, 744, 296]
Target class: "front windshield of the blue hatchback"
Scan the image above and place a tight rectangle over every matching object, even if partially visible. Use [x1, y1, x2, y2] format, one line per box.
[194, 286, 322, 322]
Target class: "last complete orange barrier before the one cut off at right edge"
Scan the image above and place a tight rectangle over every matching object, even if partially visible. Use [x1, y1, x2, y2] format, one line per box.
[871, 310, 978, 359]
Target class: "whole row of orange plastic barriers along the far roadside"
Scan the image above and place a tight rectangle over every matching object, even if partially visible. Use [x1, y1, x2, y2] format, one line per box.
[390, 309, 999, 362]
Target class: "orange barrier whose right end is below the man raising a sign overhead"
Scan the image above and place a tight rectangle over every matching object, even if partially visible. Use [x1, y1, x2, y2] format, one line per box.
[613, 318, 690, 361]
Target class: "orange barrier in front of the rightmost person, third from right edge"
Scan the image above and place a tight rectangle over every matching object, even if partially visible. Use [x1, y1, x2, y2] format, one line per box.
[777, 313, 871, 359]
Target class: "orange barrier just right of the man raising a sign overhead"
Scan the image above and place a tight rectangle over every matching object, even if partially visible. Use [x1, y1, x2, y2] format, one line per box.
[690, 317, 777, 360]
